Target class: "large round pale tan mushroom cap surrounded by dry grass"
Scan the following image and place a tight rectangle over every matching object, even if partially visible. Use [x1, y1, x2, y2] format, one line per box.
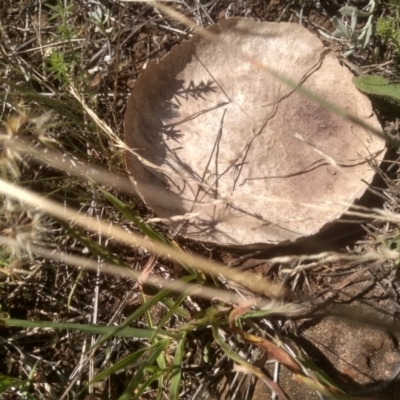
[125, 18, 385, 247]
